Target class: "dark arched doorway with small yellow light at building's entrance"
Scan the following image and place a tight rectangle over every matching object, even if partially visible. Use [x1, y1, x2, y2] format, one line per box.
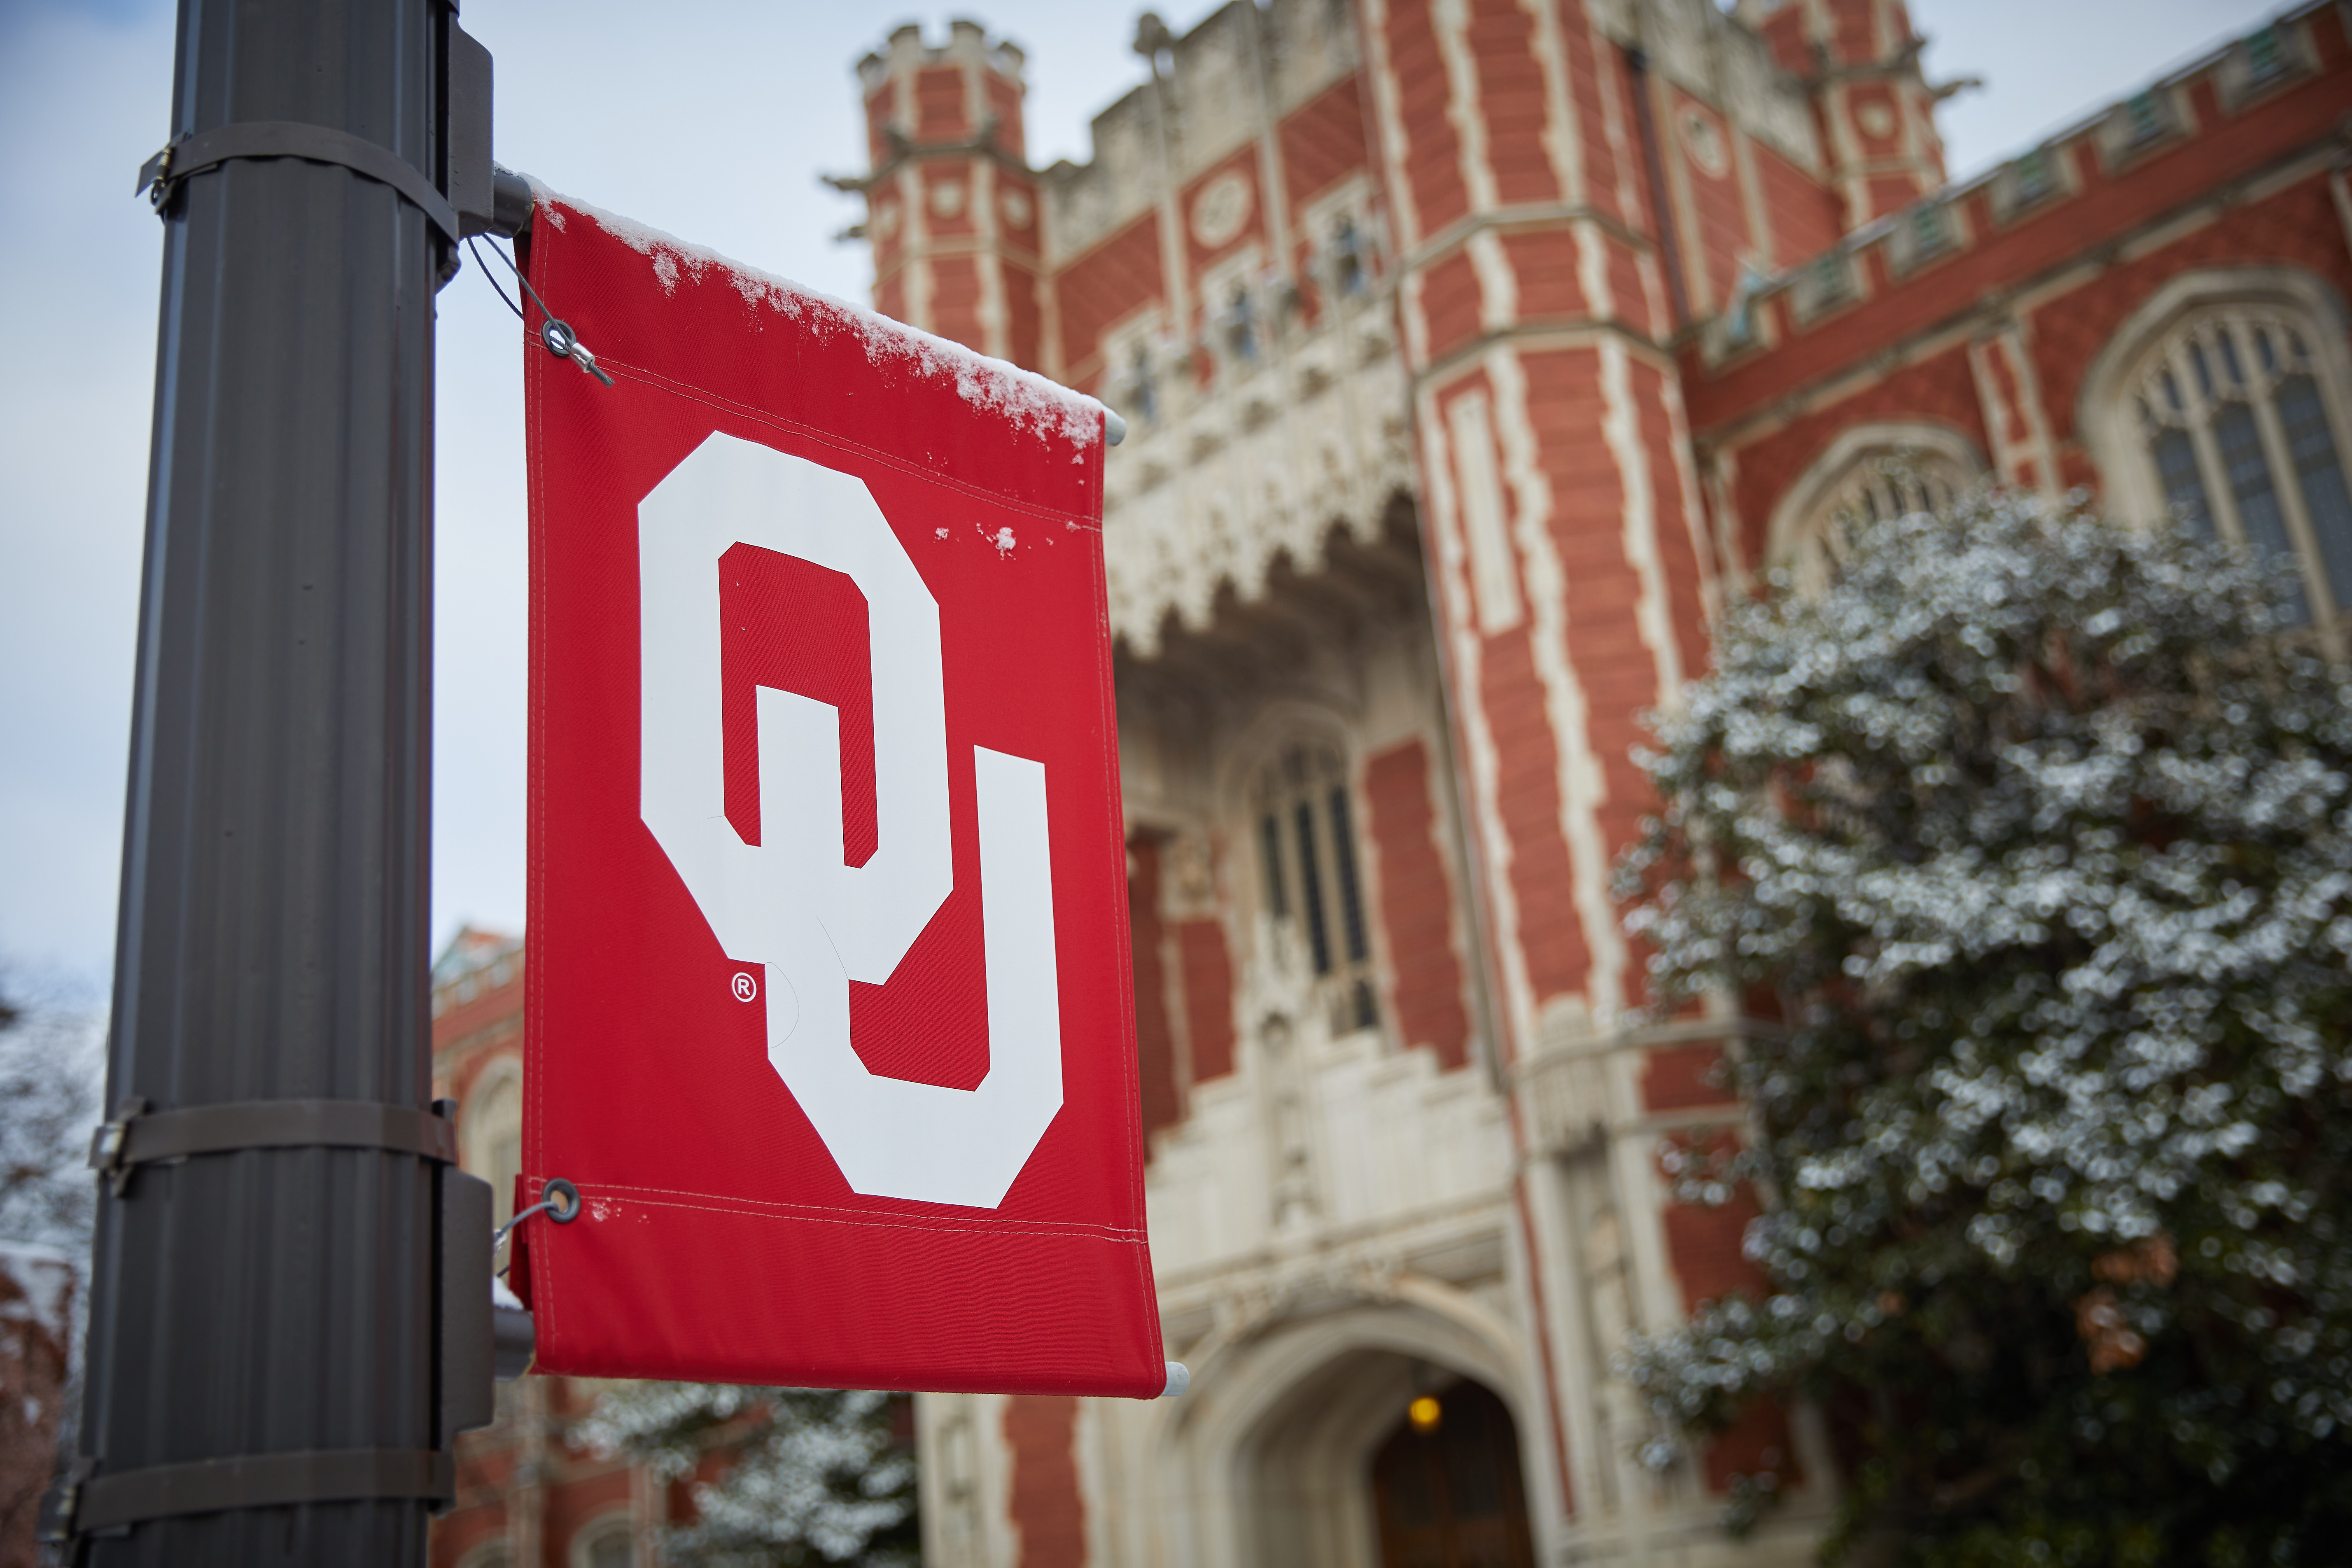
[1371, 1382, 1536, 1568]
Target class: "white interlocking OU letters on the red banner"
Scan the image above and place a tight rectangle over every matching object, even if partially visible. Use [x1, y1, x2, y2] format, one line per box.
[637, 435, 1061, 1209]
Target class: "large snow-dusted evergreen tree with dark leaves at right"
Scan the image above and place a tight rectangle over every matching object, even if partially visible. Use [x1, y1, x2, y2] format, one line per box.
[1621, 494, 2352, 1568]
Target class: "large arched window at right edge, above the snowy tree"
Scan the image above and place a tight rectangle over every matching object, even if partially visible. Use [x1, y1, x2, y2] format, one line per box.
[2126, 303, 2352, 621]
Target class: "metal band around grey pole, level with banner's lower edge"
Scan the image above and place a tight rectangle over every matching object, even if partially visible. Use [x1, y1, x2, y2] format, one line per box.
[89, 1095, 456, 1197]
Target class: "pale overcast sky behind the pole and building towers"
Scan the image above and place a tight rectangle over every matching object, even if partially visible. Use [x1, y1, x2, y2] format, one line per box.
[0, 0, 2279, 992]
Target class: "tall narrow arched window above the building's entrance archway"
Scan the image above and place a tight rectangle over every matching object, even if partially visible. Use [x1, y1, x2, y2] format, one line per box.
[1249, 738, 1381, 1034]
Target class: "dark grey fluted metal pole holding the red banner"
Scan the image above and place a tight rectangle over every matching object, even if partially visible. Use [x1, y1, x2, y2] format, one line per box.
[56, 0, 506, 1568]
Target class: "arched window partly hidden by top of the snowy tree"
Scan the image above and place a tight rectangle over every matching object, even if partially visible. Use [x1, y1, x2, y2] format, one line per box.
[1766, 423, 1985, 590]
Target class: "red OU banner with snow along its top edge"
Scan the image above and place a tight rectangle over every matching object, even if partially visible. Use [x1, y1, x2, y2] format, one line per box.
[513, 193, 1181, 1396]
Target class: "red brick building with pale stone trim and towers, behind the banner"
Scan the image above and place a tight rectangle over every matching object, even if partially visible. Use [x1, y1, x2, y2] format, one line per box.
[842, 0, 2352, 1568]
